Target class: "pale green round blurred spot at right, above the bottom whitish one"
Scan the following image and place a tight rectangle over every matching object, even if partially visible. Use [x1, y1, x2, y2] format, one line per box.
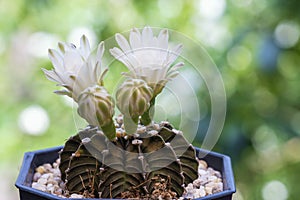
[252, 126, 278, 153]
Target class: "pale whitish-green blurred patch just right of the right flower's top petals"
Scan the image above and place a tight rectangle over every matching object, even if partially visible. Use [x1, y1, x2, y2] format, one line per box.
[195, 20, 232, 51]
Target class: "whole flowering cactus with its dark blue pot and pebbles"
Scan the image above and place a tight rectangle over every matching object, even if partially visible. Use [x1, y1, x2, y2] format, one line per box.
[16, 27, 235, 200]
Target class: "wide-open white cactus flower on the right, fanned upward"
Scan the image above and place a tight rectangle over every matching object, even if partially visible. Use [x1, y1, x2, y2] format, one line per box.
[110, 27, 183, 96]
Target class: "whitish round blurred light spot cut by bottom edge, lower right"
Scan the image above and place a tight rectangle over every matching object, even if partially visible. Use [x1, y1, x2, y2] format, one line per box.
[262, 180, 289, 200]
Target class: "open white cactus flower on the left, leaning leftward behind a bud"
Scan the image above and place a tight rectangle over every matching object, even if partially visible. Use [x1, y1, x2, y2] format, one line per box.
[43, 35, 106, 102]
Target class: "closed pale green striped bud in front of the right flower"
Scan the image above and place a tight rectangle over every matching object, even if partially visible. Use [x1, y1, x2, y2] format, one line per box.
[116, 79, 153, 118]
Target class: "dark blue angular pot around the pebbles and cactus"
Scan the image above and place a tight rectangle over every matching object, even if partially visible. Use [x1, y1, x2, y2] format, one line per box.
[16, 146, 235, 200]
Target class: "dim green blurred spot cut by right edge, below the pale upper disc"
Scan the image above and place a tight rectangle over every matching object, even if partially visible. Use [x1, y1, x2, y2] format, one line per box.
[277, 51, 300, 80]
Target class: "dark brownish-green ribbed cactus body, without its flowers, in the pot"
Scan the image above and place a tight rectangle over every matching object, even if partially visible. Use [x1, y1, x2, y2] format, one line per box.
[60, 118, 198, 198]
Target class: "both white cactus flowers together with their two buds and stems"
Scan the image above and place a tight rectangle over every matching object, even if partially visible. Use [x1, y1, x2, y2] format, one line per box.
[43, 27, 183, 140]
